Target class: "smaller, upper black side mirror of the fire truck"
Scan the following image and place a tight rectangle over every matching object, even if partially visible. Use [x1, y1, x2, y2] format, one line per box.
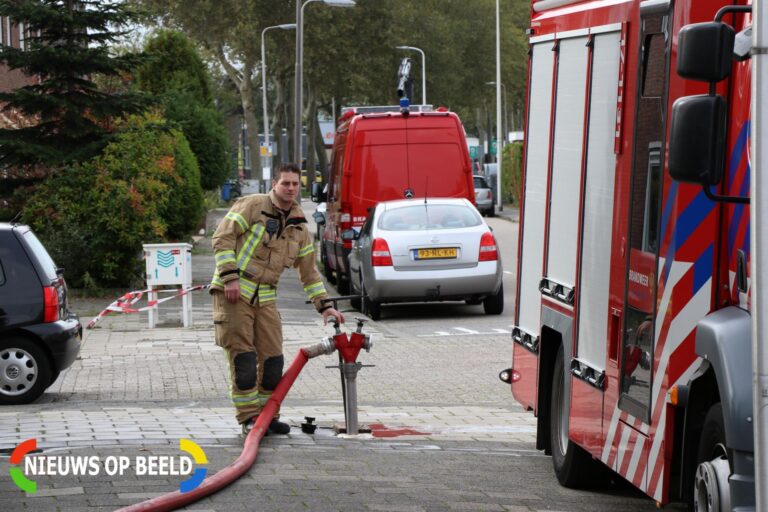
[677, 21, 736, 82]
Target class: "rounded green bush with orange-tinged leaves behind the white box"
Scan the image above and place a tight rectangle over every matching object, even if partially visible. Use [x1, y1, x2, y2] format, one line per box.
[23, 114, 202, 287]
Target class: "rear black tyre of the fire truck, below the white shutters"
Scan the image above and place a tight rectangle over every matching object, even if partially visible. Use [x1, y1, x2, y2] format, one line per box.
[549, 345, 597, 487]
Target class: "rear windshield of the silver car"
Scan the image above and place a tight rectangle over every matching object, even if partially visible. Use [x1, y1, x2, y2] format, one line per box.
[378, 204, 483, 231]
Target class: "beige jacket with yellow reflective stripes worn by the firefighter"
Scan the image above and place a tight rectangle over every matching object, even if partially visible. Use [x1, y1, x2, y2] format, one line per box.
[211, 192, 329, 311]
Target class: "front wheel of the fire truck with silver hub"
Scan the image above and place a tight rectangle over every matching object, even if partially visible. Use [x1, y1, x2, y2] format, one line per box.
[693, 403, 732, 511]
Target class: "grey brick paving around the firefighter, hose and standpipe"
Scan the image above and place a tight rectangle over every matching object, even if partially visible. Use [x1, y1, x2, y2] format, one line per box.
[0, 203, 664, 512]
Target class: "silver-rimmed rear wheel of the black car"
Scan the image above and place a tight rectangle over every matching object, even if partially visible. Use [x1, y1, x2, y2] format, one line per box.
[0, 338, 51, 405]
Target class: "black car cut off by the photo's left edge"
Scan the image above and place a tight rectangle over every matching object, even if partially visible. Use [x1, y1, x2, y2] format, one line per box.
[0, 223, 82, 405]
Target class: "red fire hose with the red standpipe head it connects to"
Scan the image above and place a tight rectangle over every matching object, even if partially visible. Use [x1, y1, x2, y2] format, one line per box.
[115, 320, 372, 512]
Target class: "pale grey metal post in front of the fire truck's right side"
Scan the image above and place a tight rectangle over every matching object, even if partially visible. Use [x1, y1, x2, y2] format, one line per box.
[750, 0, 768, 512]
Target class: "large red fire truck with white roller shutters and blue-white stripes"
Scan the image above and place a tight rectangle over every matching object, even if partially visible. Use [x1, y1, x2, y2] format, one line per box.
[500, 0, 768, 510]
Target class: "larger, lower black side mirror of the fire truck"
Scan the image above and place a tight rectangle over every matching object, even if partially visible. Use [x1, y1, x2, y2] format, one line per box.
[669, 95, 727, 186]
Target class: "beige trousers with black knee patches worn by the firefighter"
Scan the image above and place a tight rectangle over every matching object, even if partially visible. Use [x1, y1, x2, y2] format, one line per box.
[213, 290, 283, 423]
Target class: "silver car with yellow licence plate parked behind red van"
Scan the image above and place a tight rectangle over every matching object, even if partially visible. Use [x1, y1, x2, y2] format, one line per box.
[342, 198, 504, 320]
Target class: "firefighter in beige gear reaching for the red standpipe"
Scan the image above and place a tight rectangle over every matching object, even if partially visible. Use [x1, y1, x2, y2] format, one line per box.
[211, 164, 344, 434]
